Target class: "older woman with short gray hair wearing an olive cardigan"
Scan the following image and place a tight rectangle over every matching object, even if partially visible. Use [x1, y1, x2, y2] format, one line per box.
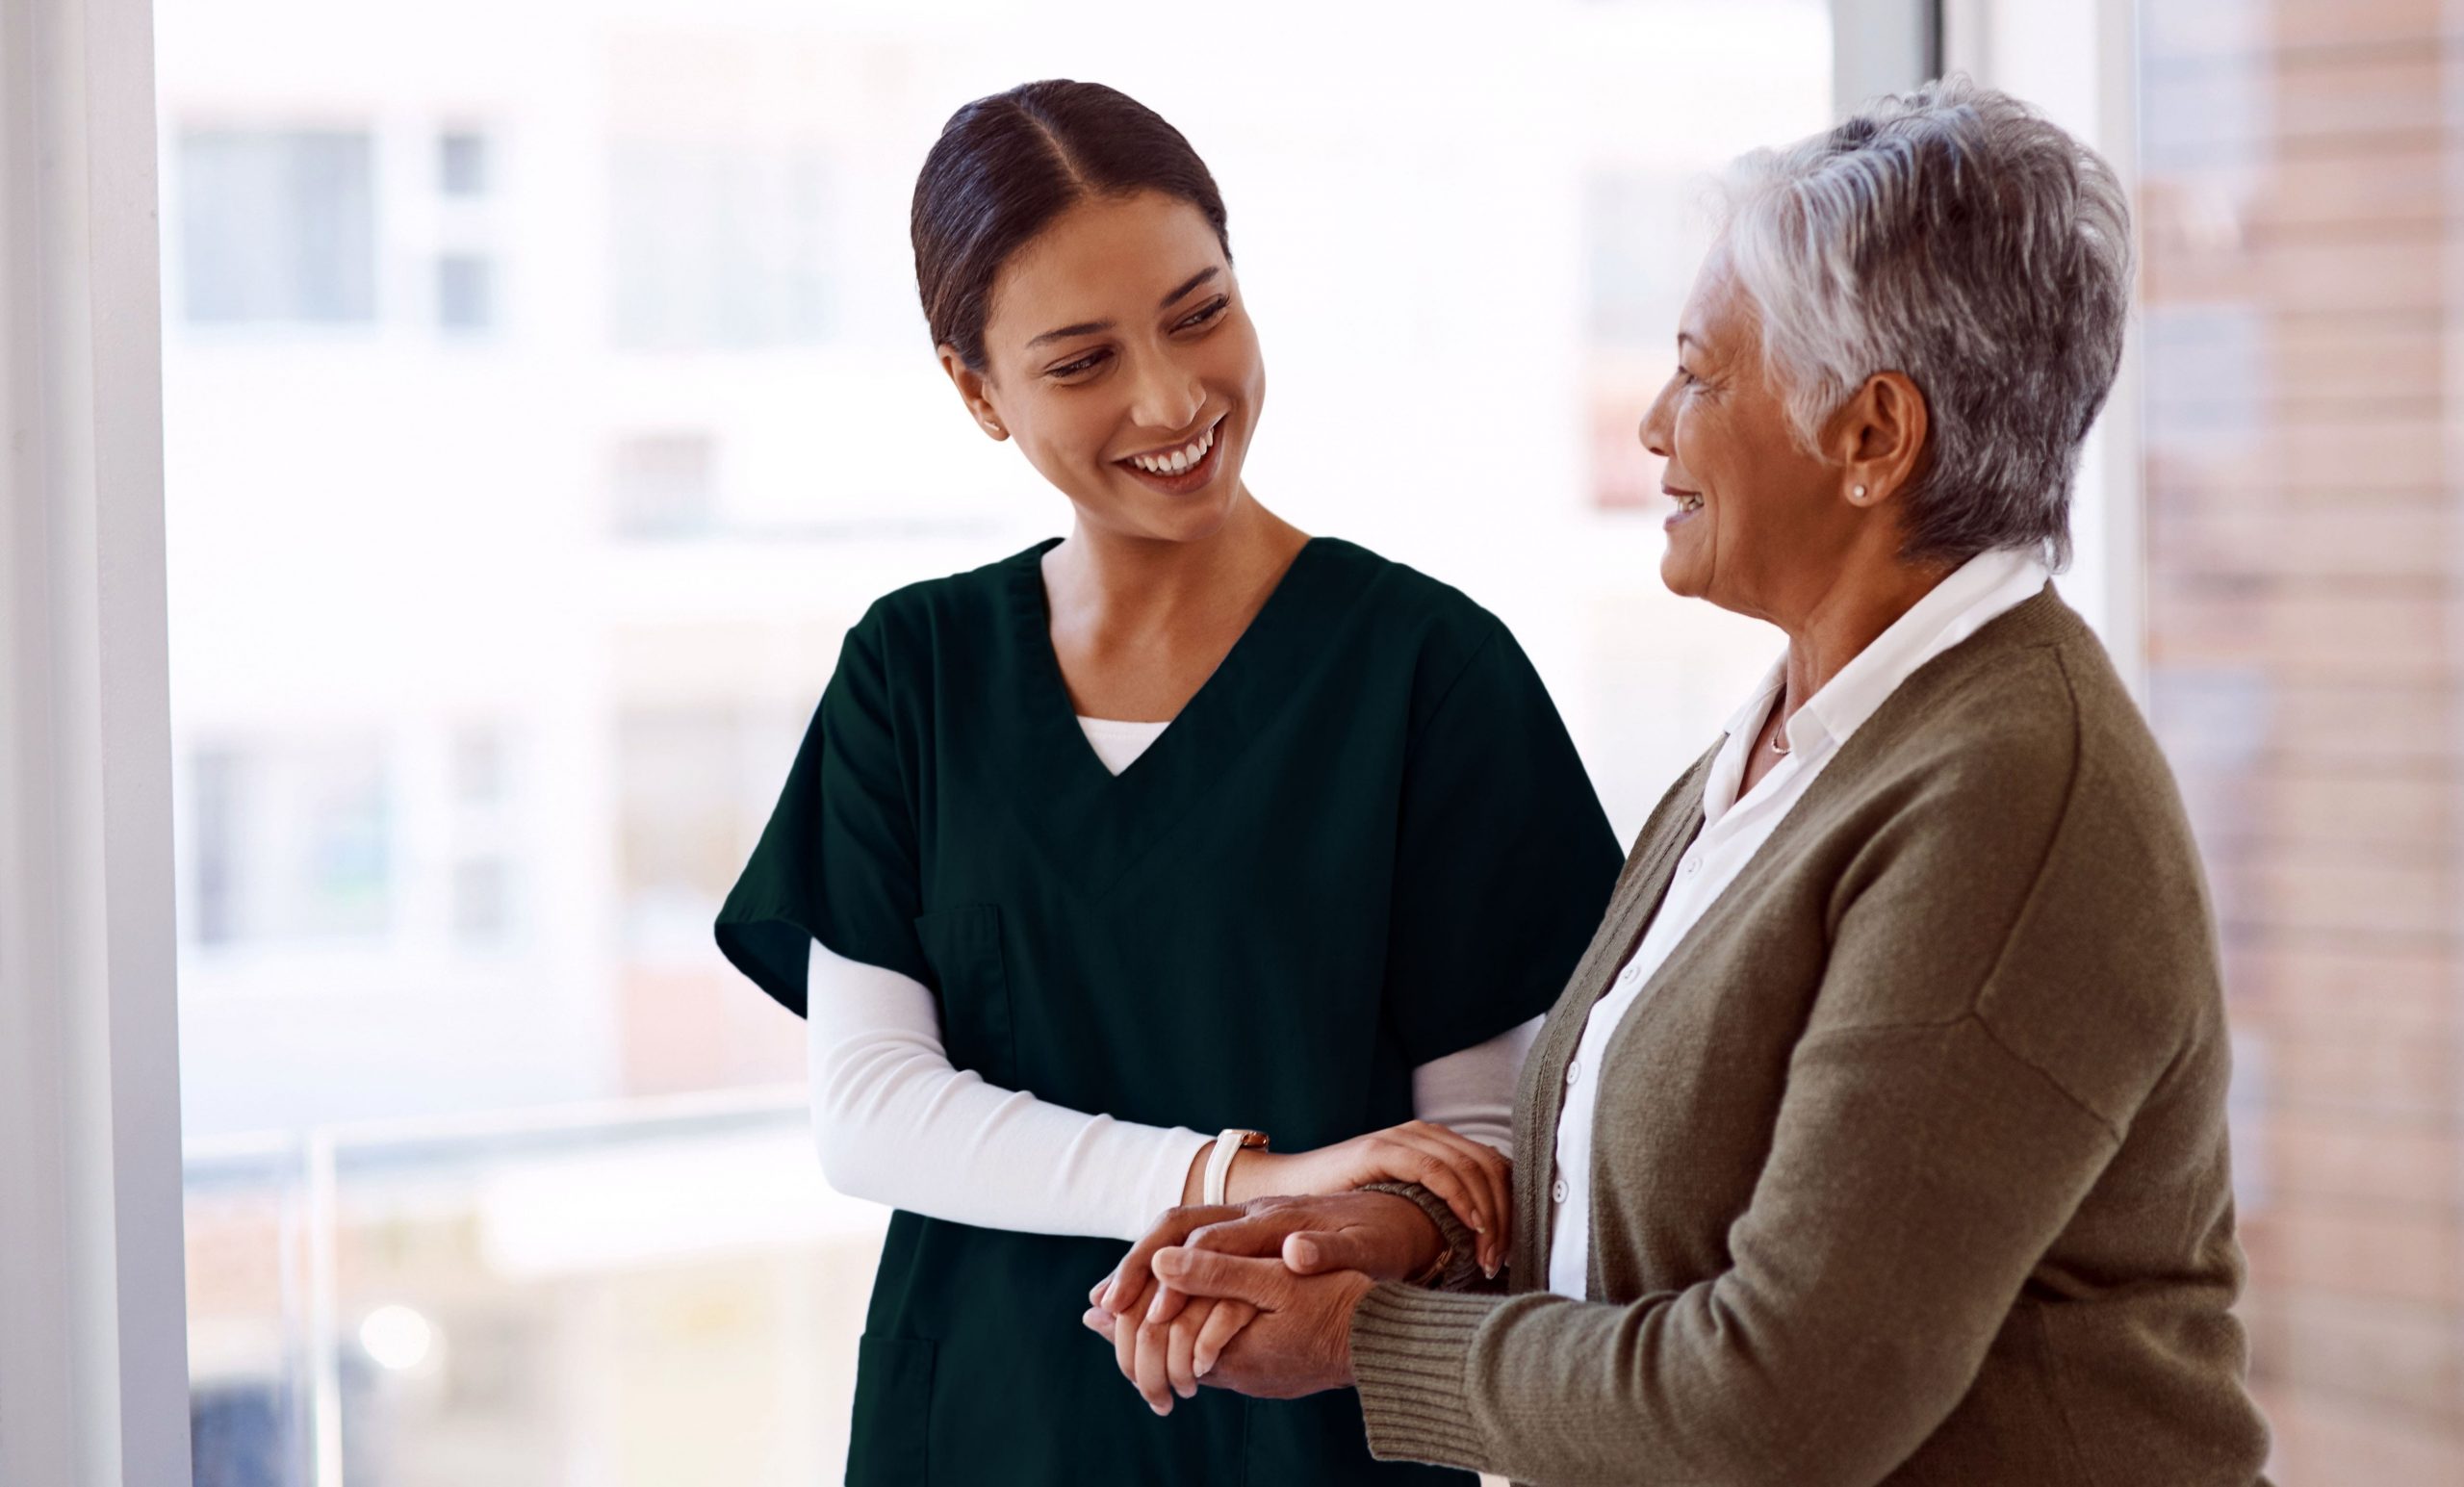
[1087, 81, 2267, 1487]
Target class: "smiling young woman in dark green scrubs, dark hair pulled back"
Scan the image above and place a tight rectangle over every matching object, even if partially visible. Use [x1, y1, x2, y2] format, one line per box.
[717, 81, 1621, 1487]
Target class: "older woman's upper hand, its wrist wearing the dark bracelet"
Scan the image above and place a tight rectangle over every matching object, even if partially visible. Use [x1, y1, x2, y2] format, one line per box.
[1084, 1192, 1444, 1416]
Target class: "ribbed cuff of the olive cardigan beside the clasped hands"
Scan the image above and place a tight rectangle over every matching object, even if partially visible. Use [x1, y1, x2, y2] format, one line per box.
[1350, 1280, 1505, 1470]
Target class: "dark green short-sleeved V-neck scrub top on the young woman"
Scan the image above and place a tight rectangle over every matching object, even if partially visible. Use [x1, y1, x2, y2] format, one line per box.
[717, 537, 1621, 1487]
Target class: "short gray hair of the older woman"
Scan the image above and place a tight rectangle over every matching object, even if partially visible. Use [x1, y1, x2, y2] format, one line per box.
[1725, 76, 2131, 569]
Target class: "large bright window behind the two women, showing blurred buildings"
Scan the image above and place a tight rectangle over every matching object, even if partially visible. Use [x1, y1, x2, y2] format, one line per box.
[158, 0, 1831, 1487]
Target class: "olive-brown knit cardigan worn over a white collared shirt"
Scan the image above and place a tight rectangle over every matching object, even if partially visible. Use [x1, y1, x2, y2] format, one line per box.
[1350, 586, 2267, 1487]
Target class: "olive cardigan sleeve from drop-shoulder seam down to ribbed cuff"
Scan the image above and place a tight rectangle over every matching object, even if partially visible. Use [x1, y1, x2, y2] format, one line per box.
[1352, 1019, 2114, 1487]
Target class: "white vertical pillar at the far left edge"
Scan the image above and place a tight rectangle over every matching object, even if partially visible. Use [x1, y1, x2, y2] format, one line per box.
[0, 0, 190, 1487]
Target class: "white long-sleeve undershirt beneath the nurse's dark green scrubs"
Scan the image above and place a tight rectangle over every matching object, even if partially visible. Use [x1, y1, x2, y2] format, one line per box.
[806, 719, 1540, 1239]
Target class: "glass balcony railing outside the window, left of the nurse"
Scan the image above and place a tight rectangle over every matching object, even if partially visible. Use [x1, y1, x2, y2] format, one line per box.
[188, 1086, 887, 1487]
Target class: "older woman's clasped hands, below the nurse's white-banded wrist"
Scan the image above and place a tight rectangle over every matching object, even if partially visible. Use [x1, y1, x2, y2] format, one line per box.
[1087, 1192, 1458, 1416]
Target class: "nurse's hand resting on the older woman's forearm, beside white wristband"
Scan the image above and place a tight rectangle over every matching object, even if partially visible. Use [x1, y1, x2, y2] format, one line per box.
[1183, 1120, 1515, 1275]
